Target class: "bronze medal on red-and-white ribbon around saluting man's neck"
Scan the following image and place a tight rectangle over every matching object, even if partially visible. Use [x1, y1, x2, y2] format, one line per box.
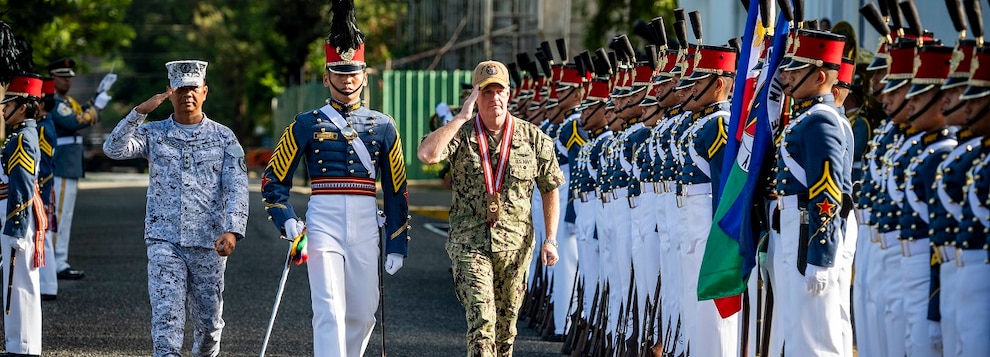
[474, 116, 515, 227]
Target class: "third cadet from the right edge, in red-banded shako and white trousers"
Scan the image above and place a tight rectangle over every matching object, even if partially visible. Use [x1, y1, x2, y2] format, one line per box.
[898, 44, 956, 356]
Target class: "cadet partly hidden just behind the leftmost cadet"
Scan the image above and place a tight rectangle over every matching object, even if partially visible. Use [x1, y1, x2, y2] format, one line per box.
[37, 77, 58, 300]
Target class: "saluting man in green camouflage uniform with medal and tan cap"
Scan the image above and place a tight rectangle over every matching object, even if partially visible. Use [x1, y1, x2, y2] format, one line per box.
[419, 61, 564, 356]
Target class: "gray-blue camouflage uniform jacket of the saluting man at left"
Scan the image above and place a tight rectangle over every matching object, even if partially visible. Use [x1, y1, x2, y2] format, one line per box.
[103, 110, 248, 249]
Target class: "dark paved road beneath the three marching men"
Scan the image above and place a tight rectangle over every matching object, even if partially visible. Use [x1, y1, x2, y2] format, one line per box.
[21, 177, 560, 356]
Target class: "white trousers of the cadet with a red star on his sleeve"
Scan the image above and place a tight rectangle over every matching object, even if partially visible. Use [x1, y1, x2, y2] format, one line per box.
[774, 206, 852, 356]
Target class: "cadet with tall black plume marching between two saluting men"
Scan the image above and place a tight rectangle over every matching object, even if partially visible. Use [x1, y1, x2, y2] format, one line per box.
[261, 1, 408, 356]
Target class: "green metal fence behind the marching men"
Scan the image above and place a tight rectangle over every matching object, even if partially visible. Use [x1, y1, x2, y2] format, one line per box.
[272, 71, 471, 180]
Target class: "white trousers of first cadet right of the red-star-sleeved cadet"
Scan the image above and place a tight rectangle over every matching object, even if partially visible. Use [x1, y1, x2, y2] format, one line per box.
[852, 209, 883, 357]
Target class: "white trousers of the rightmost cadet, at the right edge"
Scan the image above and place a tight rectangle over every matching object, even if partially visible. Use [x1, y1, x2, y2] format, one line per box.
[942, 249, 990, 357]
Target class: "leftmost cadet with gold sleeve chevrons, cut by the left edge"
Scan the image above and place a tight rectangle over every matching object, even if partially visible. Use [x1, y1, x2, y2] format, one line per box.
[0, 74, 46, 356]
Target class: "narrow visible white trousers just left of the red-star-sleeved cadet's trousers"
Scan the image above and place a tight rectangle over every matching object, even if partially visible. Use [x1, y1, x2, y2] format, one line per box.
[766, 200, 794, 356]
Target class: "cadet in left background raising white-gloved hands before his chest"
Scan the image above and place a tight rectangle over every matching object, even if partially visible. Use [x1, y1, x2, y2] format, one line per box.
[45, 58, 117, 279]
